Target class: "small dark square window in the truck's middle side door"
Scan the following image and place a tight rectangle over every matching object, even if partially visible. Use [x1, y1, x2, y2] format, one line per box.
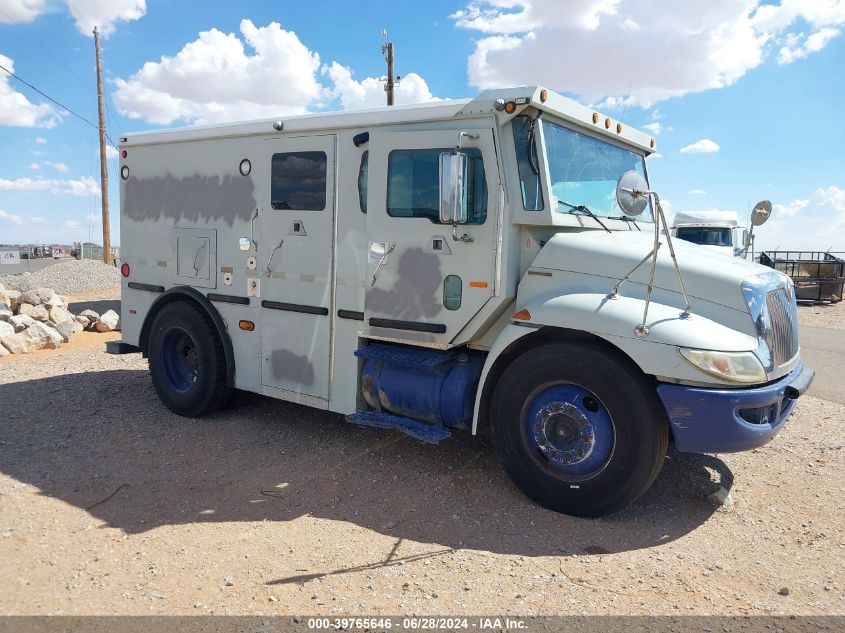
[270, 152, 327, 211]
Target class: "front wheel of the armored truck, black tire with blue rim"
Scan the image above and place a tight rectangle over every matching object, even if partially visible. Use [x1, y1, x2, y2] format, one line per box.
[490, 341, 669, 517]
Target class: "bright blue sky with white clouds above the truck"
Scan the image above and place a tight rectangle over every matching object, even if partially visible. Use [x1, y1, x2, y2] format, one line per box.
[0, 0, 845, 251]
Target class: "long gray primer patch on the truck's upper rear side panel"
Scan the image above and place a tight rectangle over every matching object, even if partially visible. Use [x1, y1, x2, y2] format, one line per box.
[123, 175, 256, 226]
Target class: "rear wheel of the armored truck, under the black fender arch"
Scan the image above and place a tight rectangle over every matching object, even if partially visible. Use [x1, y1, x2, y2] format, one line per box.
[147, 301, 233, 418]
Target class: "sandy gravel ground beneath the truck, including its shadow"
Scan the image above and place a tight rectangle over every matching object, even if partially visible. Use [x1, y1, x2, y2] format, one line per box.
[0, 346, 845, 615]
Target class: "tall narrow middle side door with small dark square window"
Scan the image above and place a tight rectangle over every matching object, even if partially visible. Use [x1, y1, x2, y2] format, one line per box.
[258, 135, 336, 406]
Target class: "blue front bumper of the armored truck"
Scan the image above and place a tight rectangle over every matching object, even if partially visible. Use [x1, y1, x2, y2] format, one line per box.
[657, 364, 815, 453]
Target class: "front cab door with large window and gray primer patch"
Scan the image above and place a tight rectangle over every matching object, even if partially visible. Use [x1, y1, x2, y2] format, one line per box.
[364, 128, 499, 347]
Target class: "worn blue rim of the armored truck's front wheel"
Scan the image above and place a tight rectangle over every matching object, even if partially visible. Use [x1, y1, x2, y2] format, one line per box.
[523, 384, 616, 479]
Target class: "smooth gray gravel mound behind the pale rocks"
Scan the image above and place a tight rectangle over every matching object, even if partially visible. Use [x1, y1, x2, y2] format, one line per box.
[0, 259, 120, 295]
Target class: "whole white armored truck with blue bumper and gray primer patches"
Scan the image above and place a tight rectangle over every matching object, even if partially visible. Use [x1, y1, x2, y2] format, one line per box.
[109, 87, 813, 516]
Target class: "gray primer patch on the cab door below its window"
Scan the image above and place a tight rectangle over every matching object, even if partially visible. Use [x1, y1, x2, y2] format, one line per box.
[367, 248, 443, 321]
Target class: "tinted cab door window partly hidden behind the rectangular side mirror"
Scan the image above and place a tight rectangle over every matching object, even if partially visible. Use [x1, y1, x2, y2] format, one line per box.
[387, 147, 487, 224]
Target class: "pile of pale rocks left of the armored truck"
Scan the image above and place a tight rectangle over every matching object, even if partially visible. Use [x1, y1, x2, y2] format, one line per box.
[0, 285, 120, 356]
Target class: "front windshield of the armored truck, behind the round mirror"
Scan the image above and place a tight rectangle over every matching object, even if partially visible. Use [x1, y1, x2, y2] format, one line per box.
[541, 119, 652, 222]
